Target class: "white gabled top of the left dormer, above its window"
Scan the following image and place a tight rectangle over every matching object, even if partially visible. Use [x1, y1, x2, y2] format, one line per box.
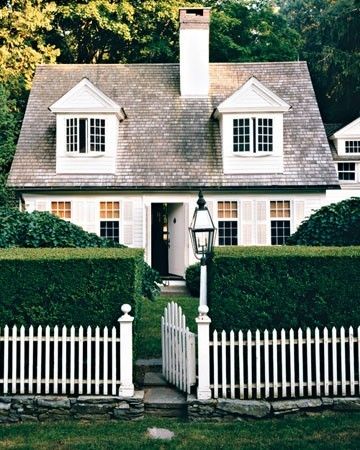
[49, 77, 125, 120]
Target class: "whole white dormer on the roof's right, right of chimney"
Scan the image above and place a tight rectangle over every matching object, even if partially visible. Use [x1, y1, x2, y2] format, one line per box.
[214, 77, 291, 174]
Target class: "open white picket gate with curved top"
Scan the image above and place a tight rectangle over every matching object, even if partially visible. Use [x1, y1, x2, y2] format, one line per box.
[161, 302, 196, 394]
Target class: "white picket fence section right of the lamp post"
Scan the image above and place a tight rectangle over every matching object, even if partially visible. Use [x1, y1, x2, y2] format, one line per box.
[210, 327, 360, 399]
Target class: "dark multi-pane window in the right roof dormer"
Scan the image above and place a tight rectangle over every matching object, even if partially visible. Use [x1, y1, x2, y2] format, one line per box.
[233, 118, 273, 154]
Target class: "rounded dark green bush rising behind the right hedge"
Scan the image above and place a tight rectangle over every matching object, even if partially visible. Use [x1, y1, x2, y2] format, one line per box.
[287, 197, 360, 246]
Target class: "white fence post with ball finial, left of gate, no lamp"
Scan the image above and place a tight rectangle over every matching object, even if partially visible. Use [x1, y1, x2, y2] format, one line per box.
[119, 303, 134, 397]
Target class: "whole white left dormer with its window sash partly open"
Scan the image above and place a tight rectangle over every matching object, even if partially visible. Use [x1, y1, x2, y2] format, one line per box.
[49, 78, 126, 173]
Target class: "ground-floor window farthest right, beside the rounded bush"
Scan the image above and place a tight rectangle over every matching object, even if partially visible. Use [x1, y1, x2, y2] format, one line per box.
[270, 200, 291, 245]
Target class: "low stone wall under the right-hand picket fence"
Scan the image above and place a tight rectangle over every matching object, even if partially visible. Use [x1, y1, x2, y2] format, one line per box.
[188, 396, 360, 421]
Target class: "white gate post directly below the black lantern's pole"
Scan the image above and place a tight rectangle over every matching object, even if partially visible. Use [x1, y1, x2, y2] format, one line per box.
[195, 305, 211, 400]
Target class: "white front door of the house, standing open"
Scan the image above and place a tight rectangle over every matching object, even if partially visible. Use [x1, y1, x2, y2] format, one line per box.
[168, 203, 186, 277]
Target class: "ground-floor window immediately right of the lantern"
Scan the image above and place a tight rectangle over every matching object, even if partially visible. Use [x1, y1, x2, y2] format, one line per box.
[218, 201, 238, 245]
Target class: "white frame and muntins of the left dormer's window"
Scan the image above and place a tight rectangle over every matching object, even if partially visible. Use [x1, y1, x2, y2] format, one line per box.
[64, 114, 108, 158]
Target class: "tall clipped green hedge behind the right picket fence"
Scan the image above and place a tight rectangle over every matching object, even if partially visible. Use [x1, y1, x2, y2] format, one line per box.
[208, 247, 360, 330]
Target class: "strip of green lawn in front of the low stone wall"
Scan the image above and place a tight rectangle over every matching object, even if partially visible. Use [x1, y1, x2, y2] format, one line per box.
[0, 413, 360, 450]
